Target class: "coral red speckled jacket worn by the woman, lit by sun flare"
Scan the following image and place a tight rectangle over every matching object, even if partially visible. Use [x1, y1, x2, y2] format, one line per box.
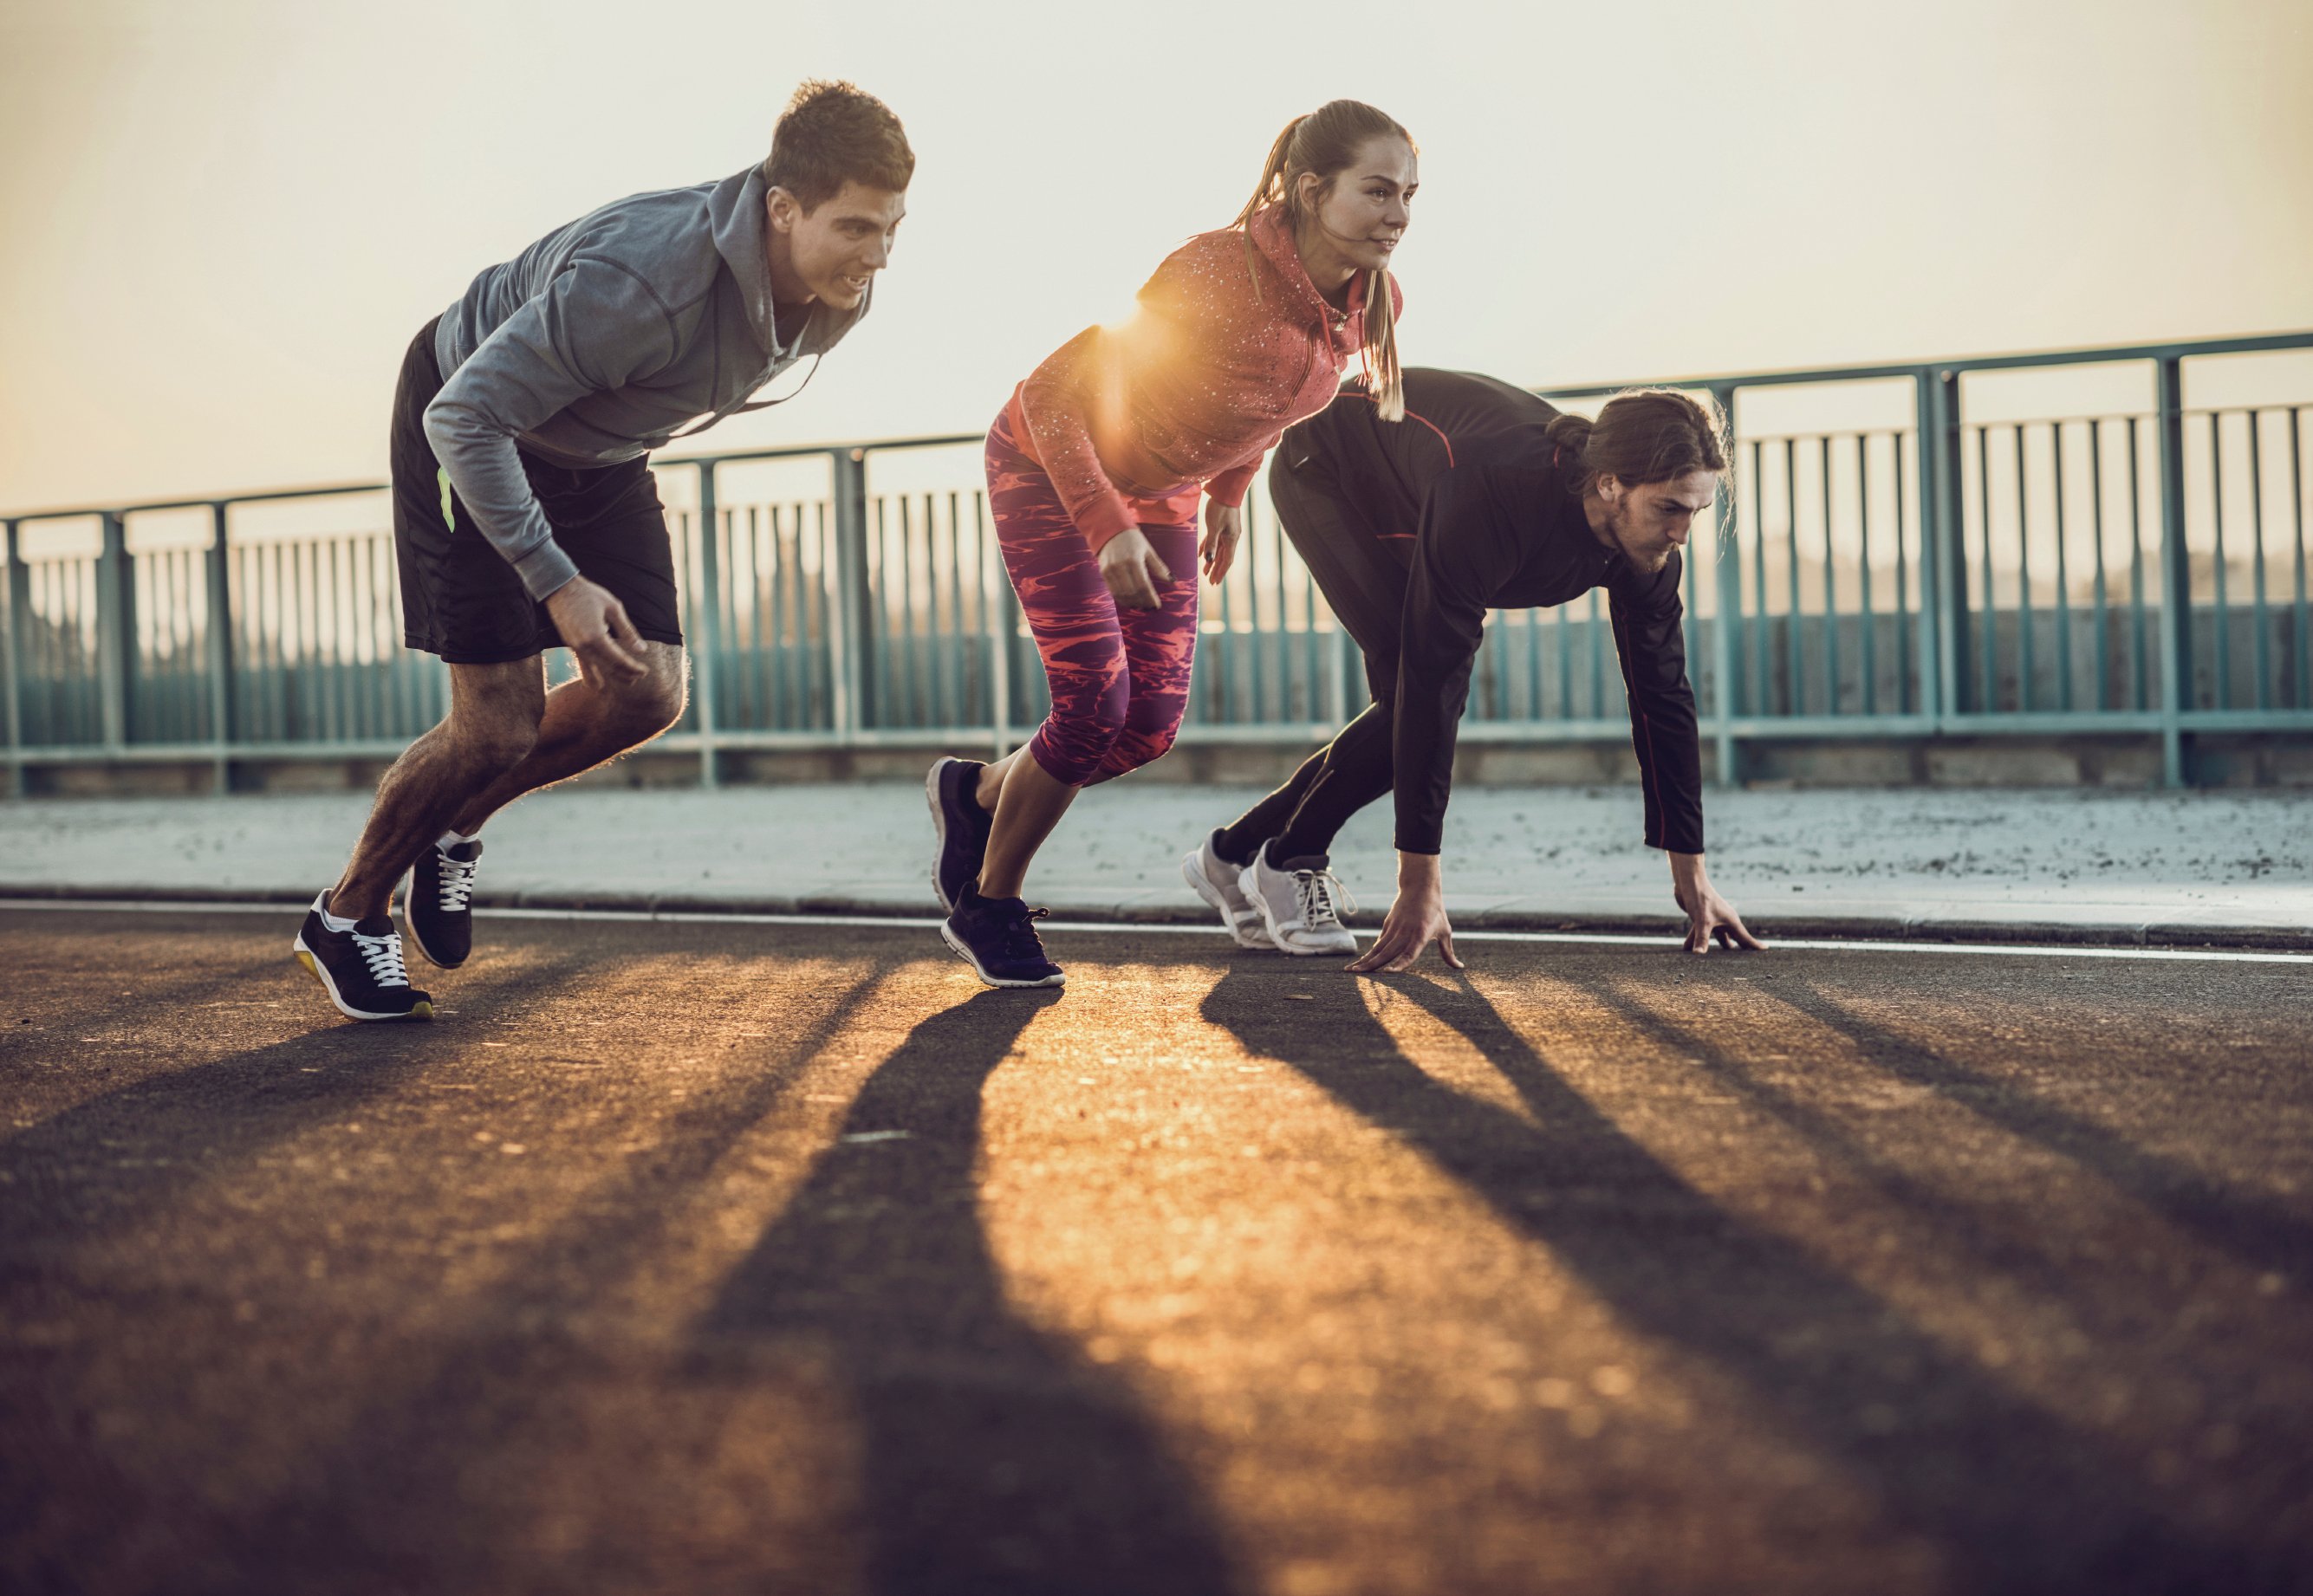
[1010, 206, 1404, 548]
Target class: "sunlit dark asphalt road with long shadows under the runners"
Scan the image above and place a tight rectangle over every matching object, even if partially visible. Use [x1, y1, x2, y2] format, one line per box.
[0, 912, 2313, 1596]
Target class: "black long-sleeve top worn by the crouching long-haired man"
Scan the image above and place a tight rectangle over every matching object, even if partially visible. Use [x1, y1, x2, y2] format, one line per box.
[1307, 370, 1702, 853]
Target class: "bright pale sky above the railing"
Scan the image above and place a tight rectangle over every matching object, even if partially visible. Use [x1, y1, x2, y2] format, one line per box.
[0, 0, 2313, 509]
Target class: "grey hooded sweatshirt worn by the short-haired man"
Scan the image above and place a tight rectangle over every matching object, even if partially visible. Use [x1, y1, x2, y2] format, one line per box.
[426, 166, 867, 599]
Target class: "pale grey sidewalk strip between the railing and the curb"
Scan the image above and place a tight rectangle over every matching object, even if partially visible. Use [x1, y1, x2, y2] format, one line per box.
[0, 780, 2313, 949]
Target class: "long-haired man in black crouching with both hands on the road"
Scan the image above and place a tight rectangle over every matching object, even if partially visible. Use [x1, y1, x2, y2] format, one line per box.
[1182, 367, 1764, 971]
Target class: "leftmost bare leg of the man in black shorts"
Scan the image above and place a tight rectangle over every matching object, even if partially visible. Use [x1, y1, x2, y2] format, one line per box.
[328, 654, 546, 920]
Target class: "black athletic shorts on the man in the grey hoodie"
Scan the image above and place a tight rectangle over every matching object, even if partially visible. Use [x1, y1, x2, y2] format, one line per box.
[391, 317, 682, 664]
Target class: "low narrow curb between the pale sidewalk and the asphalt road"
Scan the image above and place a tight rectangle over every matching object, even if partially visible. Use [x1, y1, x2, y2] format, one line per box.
[0, 881, 2313, 953]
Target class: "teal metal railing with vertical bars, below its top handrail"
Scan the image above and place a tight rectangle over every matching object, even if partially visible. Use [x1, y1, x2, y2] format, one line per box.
[0, 333, 2313, 791]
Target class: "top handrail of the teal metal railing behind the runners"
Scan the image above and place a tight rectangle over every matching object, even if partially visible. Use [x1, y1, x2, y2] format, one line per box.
[0, 328, 2313, 522]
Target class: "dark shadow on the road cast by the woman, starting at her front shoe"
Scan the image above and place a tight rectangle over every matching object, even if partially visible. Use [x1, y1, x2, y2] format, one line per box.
[692, 992, 1238, 1596]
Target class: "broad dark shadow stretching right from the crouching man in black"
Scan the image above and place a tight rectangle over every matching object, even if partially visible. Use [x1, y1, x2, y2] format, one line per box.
[1203, 971, 2290, 1592]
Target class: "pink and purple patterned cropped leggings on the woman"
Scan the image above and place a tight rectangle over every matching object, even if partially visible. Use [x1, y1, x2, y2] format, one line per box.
[988, 414, 1199, 787]
